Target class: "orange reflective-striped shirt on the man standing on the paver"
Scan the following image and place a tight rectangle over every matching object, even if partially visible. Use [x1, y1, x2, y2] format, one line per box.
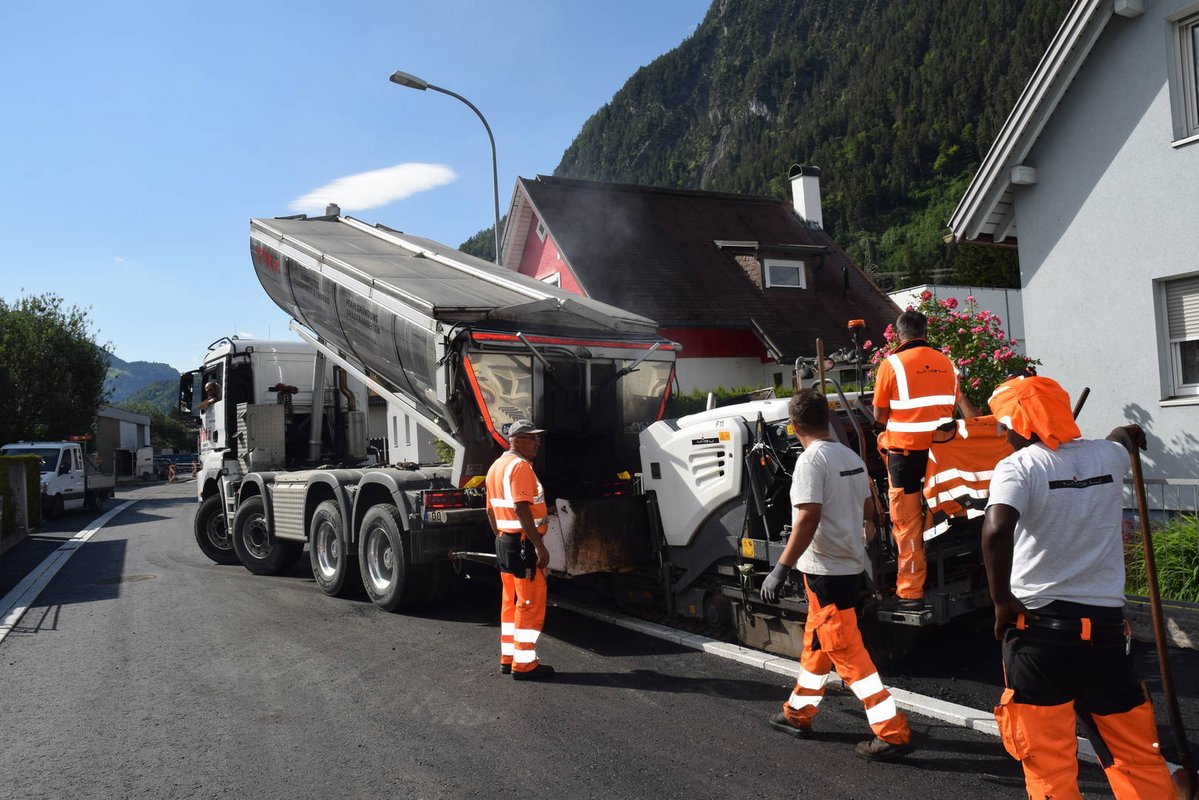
[874, 345, 958, 450]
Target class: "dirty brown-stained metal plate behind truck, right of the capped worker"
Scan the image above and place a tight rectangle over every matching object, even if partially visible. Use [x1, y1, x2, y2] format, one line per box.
[543, 494, 651, 576]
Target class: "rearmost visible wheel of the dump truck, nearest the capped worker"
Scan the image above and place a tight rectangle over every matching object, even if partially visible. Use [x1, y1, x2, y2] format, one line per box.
[359, 503, 427, 612]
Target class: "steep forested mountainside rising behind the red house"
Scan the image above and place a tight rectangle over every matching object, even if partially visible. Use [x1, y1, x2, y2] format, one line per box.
[554, 0, 1070, 288]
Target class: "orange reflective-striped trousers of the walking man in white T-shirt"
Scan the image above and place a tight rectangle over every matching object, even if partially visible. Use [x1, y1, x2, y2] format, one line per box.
[783, 576, 911, 745]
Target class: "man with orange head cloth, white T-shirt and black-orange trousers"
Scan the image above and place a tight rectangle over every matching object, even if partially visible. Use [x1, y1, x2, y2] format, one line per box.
[982, 377, 1175, 800]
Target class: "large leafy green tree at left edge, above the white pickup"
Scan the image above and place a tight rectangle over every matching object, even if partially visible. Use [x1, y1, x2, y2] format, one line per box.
[0, 294, 108, 443]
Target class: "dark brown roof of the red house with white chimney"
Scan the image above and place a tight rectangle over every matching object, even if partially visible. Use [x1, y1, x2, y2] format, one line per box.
[520, 175, 899, 361]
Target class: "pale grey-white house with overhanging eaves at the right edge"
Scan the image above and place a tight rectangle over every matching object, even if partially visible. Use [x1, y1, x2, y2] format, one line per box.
[950, 0, 1199, 479]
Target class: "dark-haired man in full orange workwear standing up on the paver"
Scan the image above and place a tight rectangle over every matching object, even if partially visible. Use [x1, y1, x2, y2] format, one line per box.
[874, 311, 974, 610]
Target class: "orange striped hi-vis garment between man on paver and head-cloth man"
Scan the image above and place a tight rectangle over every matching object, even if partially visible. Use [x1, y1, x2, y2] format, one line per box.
[924, 415, 1012, 540]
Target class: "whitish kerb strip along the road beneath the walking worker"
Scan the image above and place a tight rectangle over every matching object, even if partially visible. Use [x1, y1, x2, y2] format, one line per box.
[549, 600, 1180, 772]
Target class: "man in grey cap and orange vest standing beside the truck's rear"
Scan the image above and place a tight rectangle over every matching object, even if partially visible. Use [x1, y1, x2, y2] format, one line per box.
[486, 420, 554, 680]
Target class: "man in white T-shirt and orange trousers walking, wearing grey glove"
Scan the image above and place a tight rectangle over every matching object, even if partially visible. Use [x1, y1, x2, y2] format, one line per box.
[761, 389, 912, 760]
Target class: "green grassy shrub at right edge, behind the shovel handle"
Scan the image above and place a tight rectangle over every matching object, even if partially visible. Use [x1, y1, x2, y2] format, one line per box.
[1125, 515, 1199, 603]
